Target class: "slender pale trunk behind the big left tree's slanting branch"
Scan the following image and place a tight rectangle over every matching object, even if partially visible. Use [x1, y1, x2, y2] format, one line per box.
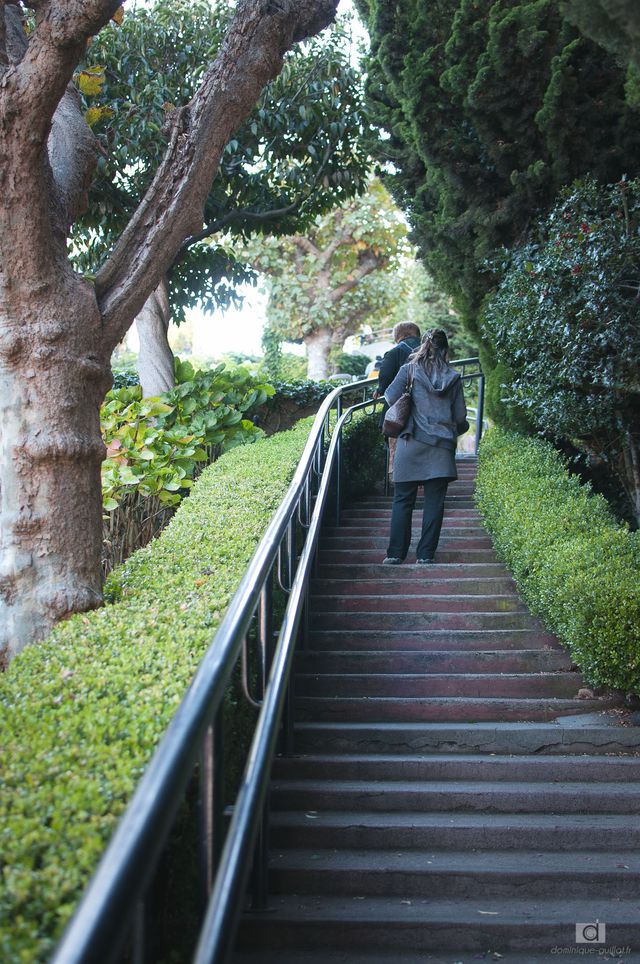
[136, 278, 175, 398]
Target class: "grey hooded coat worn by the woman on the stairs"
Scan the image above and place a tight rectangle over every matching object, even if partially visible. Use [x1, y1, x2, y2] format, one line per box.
[385, 362, 469, 482]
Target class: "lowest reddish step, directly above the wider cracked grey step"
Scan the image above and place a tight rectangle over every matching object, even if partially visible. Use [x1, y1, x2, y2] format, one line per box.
[295, 696, 617, 723]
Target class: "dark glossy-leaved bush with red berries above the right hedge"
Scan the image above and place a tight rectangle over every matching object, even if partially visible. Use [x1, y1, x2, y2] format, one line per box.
[483, 178, 640, 513]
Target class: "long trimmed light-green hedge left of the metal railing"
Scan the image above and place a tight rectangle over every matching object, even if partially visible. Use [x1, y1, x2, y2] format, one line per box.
[0, 422, 309, 964]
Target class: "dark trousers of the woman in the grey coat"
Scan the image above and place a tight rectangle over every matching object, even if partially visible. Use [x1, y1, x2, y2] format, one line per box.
[387, 479, 449, 559]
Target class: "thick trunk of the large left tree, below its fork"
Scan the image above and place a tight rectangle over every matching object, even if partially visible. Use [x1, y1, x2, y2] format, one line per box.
[0, 272, 110, 658]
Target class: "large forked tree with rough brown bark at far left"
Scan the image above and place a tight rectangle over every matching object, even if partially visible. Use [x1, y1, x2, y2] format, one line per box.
[0, 0, 337, 661]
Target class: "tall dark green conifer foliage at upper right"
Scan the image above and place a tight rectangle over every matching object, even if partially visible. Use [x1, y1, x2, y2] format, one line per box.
[358, 0, 640, 336]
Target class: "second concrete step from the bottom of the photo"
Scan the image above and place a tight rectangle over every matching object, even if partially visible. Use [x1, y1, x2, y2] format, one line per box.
[269, 848, 640, 900]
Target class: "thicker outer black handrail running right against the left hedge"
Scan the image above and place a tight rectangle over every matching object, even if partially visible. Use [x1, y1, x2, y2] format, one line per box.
[52, 379, 377, 964]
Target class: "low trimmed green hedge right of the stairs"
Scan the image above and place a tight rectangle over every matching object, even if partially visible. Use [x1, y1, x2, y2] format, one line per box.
[477, 429, 640, 695]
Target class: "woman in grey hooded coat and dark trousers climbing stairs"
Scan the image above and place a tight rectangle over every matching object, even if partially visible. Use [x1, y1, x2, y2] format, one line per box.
[383, 328, 469, 565]
